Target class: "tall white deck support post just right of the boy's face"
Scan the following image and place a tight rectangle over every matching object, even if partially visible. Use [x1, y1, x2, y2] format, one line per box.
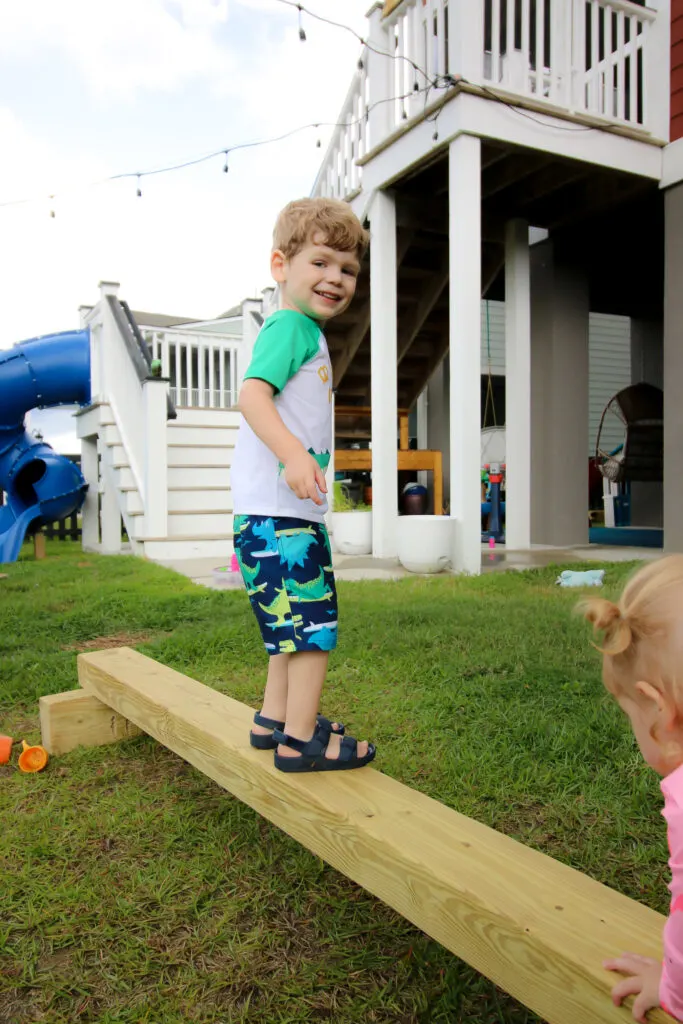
[370, 191, 398, 558]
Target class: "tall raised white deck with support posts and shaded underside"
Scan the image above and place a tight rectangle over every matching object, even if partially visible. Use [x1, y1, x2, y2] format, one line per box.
[313, 0, 683, 571]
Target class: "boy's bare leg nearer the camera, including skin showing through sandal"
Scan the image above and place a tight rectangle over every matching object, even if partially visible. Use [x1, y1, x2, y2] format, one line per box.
[280, 650, 368, 759]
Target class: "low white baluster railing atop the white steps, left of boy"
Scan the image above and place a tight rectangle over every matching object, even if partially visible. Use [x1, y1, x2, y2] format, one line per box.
[140, 327, 240, 409]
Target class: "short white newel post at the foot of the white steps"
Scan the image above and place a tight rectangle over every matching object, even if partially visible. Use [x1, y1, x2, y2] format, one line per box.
[142, 377, 168, 538]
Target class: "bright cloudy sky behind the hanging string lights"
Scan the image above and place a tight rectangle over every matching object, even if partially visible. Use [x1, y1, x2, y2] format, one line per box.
[0, 0, 371, 451]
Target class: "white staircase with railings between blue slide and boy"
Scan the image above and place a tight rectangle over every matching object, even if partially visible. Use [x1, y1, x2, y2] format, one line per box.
[76, 282, 273, 559]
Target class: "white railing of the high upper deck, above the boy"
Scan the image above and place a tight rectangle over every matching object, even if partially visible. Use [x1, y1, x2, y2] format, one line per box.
[313, 0, 670, 199]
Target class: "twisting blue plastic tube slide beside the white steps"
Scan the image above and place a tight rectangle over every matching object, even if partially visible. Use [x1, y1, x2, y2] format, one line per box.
[0, 331, 90, 562]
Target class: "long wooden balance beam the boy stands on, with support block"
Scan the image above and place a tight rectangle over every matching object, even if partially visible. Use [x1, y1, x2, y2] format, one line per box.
[40, 647, 672, 1024]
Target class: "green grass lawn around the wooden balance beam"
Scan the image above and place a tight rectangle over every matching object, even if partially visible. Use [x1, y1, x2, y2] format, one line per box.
[0, 542, 668, 1024]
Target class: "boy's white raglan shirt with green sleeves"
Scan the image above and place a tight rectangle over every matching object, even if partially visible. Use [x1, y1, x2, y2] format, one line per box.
[230, 309, 332, 522]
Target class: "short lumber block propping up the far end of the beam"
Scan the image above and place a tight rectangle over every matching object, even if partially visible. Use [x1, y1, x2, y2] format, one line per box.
[38, 690, 141, 755]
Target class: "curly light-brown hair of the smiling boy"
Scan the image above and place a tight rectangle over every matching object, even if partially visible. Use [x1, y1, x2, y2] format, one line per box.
[272, 198, 370, 262]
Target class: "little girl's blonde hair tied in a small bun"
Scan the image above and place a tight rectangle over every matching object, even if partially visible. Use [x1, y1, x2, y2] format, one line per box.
[580, 555, 683, 710]
